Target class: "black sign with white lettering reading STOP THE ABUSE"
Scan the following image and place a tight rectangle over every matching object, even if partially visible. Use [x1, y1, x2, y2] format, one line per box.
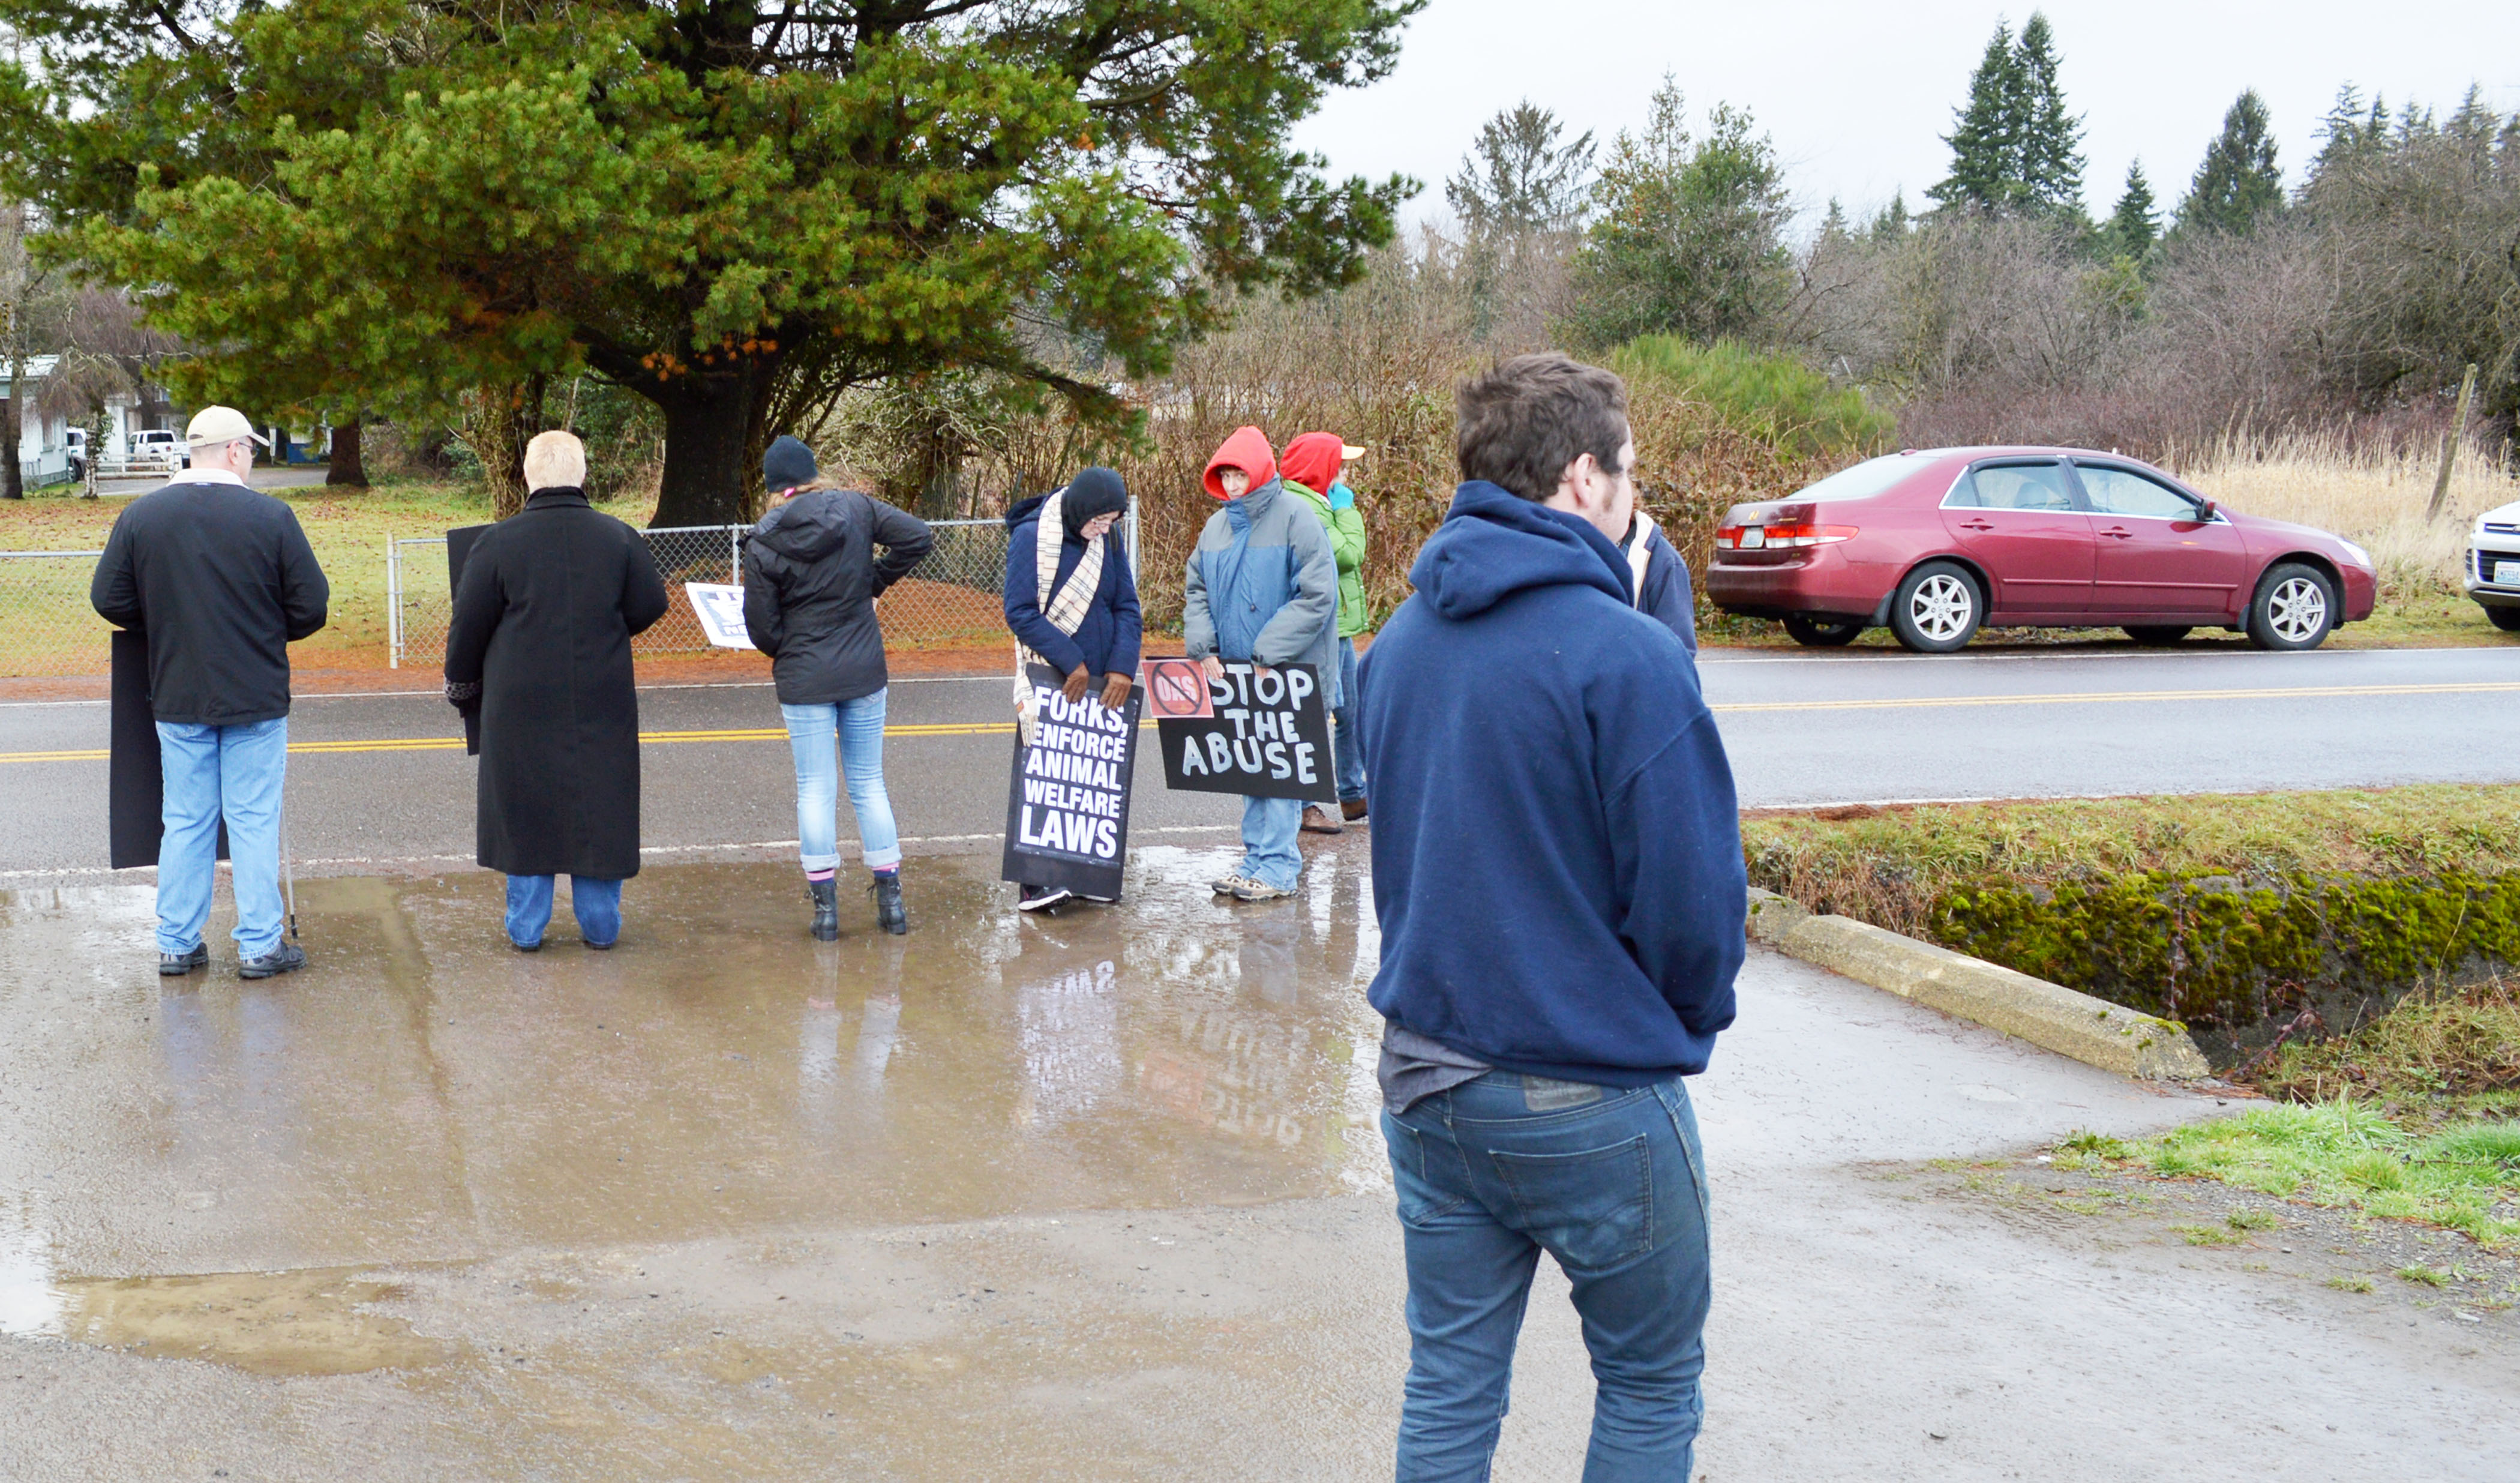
[1154, 663, 1338, 802]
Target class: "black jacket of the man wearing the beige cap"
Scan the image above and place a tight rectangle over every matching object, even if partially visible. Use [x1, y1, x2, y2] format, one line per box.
[88, 479, 332, 726]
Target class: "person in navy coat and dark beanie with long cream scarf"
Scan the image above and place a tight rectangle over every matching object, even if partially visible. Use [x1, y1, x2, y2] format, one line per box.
[1006, 469, 1142, 910]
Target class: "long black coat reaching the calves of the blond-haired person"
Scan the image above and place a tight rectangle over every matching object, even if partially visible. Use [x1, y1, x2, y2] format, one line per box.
[446, 489, 665, 880]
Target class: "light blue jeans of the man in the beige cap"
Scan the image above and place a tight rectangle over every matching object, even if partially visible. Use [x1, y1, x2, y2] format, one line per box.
[156, 716, 290, 958]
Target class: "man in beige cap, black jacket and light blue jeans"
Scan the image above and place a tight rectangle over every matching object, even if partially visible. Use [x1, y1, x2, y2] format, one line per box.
[88, 406, 332, 979]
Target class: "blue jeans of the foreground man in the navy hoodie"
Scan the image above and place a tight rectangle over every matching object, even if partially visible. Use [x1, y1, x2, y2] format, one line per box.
[1384, 1072, 1709, 1483]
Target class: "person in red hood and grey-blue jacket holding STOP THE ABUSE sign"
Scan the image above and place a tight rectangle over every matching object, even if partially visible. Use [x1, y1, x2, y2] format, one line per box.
[1182, 426, 1338, 900]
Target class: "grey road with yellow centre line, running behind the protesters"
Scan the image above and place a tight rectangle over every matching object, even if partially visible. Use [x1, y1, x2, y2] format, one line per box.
[0, 646, 2520, 877]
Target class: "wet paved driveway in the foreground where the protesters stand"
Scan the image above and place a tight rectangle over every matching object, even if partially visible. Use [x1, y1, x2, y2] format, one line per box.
[0, 837, 2520, 1483]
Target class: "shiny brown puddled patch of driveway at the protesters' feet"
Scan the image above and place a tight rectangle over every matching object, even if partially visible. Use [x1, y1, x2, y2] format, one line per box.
[0, 850, 1378, 1374]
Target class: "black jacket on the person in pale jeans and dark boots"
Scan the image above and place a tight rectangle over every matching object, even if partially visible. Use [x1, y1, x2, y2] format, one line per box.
[743, 489, 935, 706]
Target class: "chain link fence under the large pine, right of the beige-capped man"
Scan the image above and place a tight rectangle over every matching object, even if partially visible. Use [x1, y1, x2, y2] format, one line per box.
[386, 520, 1006, 669]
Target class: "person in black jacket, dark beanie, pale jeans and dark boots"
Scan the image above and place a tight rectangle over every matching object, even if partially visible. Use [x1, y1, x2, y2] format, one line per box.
[743, 436, 935, 943]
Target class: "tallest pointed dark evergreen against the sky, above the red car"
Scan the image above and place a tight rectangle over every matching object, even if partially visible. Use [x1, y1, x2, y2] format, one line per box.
[1925, 13, 2081, 220]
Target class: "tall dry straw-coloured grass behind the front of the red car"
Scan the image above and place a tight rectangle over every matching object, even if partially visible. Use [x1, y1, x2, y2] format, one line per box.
[2172, 434, 2520, 603]
